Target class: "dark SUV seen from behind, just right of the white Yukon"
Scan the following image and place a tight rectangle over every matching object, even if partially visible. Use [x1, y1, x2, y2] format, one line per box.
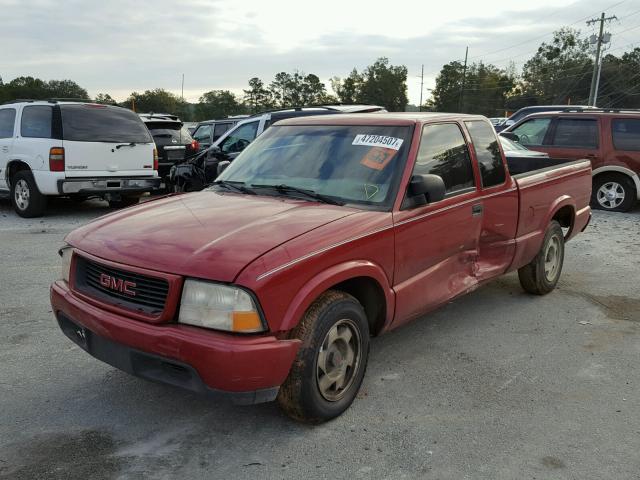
[140, 113, 200, 181]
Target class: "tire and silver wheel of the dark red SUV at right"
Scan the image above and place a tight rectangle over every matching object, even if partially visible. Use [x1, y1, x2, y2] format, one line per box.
[591, 173, 638, 212]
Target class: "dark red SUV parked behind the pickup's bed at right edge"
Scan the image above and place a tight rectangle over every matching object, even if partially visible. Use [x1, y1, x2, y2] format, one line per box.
[505, 108, 640, 212]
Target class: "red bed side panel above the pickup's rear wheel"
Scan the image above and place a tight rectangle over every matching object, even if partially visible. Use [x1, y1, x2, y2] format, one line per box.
[513, 160, 592, 238]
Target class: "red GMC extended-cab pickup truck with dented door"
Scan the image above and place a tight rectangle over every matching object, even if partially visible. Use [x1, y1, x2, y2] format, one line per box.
[51, 114, 591, 422]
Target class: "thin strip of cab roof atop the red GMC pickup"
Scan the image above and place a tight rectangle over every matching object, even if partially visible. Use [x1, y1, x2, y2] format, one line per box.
[277, 112, 488, 126]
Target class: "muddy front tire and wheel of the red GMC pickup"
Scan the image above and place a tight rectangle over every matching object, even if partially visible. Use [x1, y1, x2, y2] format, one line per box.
[278, 290, 369, 423]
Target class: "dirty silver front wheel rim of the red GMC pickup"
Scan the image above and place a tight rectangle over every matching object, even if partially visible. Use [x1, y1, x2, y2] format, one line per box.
[316, 319, 362, 402]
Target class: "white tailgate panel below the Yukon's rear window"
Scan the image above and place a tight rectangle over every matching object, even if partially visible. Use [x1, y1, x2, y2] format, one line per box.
[62, 140, 155, 177]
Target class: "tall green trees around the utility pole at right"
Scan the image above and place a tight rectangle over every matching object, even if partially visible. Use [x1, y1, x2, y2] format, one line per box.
[425, 28, 640, 116]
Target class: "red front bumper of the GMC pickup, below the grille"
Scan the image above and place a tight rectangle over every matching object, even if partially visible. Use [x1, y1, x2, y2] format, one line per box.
[50, 281, 299, 404]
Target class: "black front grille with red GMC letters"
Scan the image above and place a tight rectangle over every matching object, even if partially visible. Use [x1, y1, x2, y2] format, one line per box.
[76, 256, 169, 315]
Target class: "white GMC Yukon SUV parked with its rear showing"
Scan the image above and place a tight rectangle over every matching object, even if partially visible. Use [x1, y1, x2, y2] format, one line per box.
[0, 100, 160, 217]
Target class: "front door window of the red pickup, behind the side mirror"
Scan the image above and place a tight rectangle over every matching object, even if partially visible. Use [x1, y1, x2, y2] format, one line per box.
[413, 123, 475, 194]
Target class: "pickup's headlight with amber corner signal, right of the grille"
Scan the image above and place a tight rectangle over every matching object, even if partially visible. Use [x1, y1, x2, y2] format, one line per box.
[178, 278, 264, 333]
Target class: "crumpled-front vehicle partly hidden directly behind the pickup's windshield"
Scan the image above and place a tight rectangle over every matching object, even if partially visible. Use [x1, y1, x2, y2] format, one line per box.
[169, 105, 385, 192]
